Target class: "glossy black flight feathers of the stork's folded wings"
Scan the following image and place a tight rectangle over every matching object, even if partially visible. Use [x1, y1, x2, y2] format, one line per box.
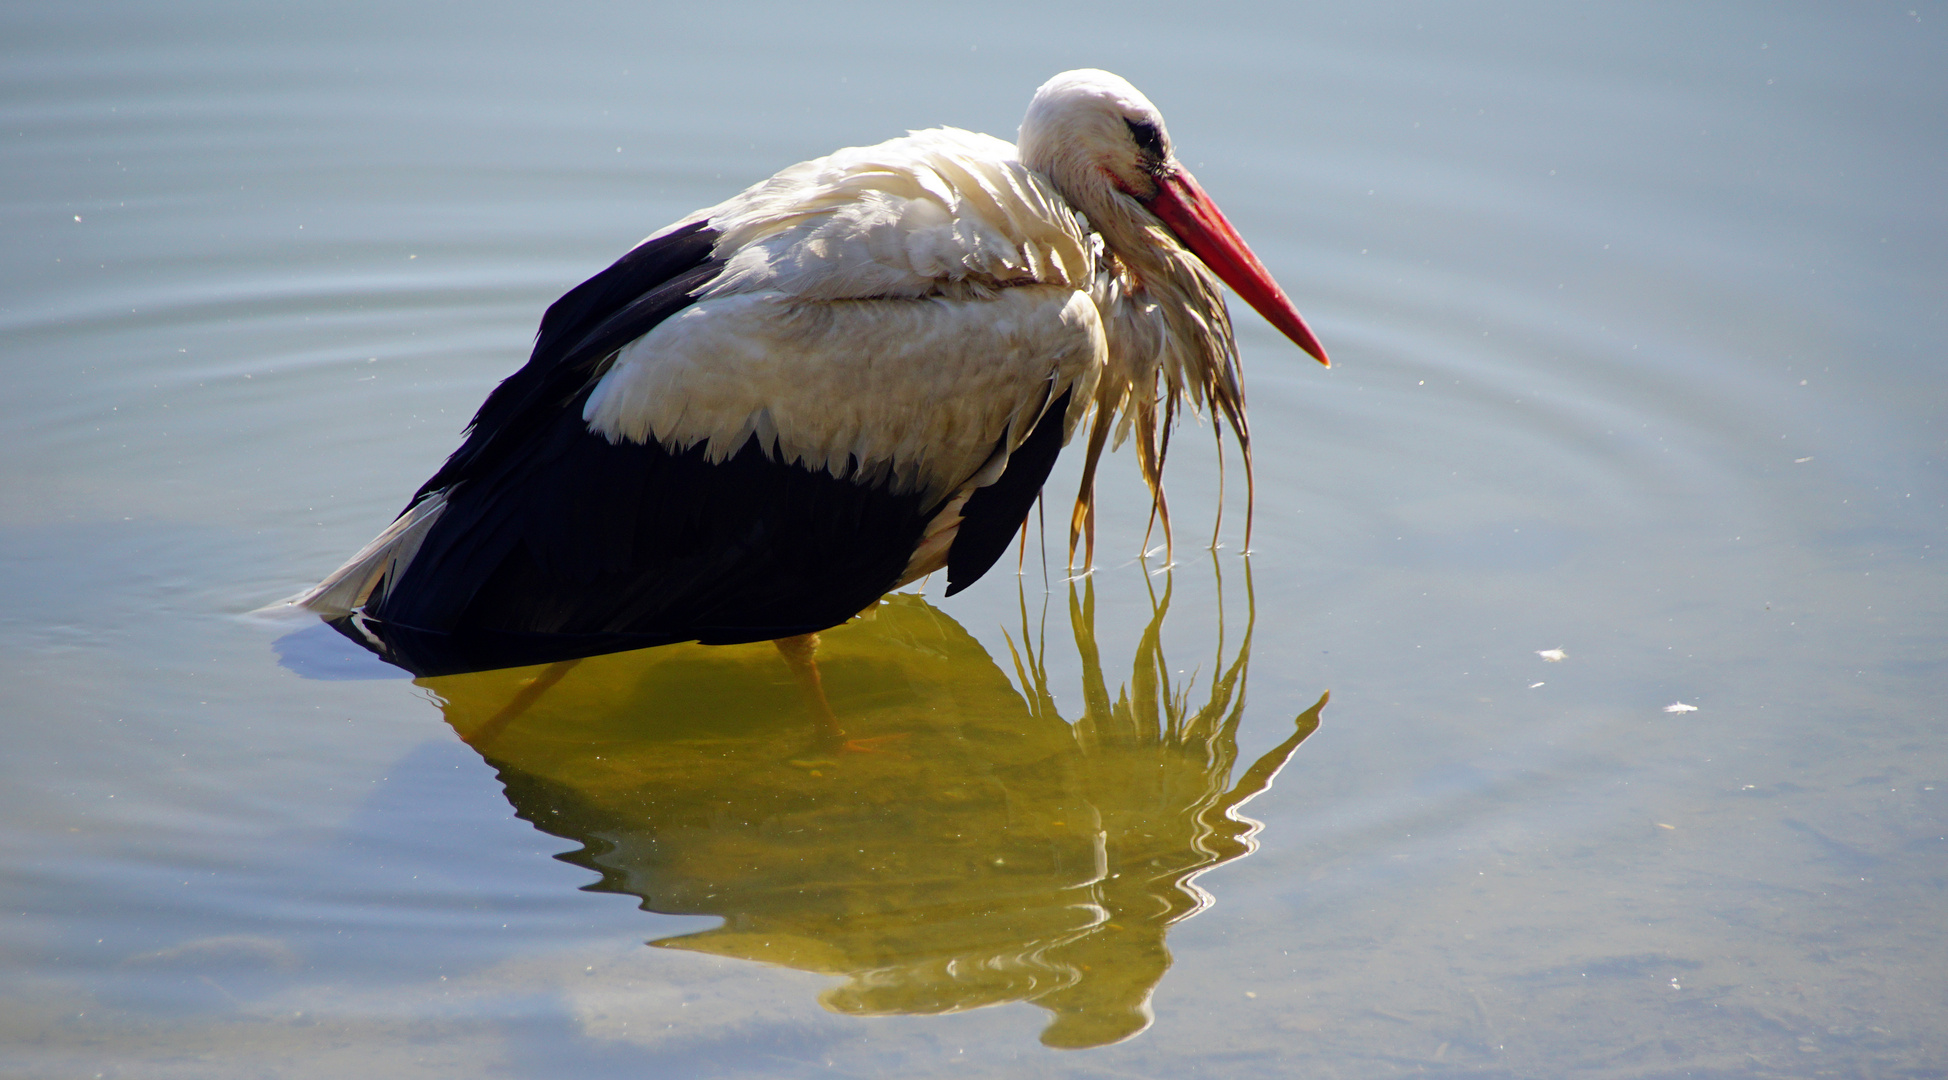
[339, 222, 1068, 675]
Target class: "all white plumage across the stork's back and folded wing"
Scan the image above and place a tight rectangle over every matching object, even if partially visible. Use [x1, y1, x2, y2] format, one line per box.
[582, 129, 1106, 497]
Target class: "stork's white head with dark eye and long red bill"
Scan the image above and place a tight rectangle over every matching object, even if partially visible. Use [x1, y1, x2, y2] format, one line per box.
[1017, 68, 1330, 366]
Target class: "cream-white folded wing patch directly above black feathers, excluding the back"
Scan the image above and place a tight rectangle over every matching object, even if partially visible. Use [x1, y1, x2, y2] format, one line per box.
[582, 285, 1106, 495]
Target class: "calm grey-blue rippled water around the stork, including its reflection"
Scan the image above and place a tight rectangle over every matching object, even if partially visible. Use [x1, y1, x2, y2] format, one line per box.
[0, 4, 1948, 1078]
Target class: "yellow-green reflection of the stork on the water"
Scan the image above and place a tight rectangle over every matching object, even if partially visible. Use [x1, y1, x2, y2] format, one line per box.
[421, 561, 1327, 1047]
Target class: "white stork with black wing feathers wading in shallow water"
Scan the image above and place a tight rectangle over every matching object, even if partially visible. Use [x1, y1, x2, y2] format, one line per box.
[290, 70, 1327, 675]
